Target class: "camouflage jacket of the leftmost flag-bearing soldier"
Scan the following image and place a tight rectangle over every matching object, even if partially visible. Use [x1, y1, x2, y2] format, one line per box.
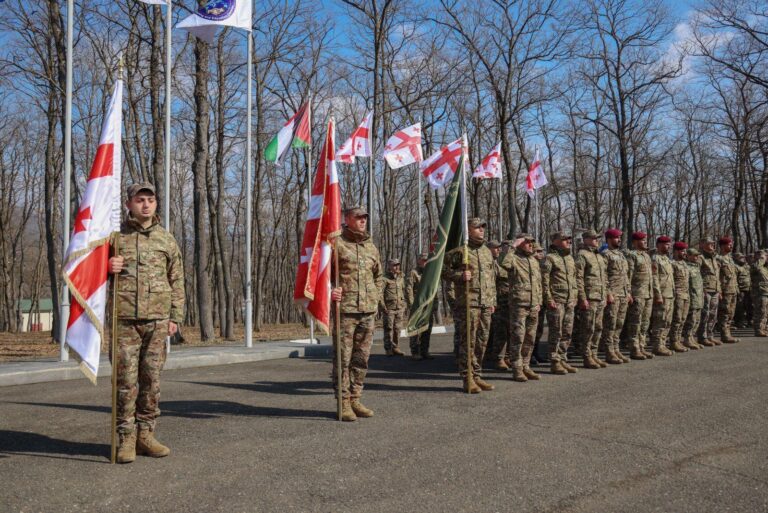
[113, 217, 184, 323]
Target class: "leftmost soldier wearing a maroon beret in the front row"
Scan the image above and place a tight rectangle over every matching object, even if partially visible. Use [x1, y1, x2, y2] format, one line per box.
[600, 228, 632, 364]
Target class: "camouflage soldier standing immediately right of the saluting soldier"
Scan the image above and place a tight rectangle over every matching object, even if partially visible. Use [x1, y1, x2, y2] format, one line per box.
[541, 232, 578, 375]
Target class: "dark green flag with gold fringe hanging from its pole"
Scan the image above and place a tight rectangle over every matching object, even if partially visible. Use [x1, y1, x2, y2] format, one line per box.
[407, 154, 466, 336]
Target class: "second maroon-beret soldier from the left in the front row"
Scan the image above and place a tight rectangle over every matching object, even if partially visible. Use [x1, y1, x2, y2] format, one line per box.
[626, 232, 653, 360]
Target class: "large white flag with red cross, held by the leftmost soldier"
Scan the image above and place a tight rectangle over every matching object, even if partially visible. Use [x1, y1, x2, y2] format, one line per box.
[63, 80, 123, 384]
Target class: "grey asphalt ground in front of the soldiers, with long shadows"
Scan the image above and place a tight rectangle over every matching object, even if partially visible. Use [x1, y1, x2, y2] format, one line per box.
[0, 330, 768, 513]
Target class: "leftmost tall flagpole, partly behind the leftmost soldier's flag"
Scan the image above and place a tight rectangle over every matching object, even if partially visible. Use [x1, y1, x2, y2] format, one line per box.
[59, 0, 75, 362]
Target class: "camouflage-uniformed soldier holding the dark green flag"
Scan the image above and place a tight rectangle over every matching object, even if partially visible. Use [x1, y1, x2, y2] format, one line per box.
[442, 217, 496, 394]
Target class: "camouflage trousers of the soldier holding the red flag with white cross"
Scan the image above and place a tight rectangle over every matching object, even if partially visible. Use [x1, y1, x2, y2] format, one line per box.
[331, 313, 376, 399]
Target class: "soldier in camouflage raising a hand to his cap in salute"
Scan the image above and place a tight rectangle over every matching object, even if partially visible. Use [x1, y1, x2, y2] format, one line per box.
[501, 233, 542, 382]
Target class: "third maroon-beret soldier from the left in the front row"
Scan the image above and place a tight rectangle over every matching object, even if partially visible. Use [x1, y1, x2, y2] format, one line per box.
[651, 235, 675, 356]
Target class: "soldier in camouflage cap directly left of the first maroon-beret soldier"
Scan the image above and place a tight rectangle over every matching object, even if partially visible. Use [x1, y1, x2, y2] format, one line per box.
[576, 230, 608, 369]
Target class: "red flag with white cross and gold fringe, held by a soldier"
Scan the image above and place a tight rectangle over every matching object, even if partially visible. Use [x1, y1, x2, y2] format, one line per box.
[293, 119, 341, 334]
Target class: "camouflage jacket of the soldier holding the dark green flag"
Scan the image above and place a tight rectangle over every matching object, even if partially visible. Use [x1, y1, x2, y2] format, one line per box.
[442, 241, 496, 308]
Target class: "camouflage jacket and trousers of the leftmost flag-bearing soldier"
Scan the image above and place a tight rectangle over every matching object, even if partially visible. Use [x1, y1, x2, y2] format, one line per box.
[117, 216, 184, 433]
